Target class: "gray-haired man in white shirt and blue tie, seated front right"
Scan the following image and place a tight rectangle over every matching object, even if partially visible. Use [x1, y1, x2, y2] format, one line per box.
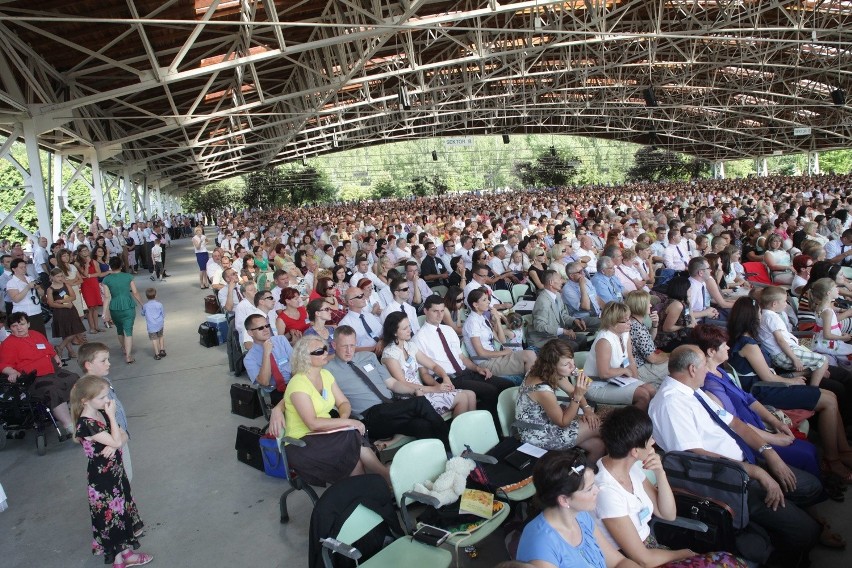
[648, 345, 822, 566]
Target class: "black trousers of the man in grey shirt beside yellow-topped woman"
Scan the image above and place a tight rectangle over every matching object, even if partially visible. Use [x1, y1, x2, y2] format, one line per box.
[363, 396, 450, 447]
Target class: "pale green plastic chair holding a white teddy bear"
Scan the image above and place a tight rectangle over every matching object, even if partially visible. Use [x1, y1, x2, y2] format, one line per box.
[390, 440, 510, 556]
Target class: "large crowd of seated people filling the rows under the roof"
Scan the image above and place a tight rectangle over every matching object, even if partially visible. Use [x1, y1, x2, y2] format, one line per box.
[198, 176, 852, 565]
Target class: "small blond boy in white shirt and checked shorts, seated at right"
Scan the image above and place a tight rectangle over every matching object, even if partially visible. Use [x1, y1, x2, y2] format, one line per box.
[757, 286, 828, 387]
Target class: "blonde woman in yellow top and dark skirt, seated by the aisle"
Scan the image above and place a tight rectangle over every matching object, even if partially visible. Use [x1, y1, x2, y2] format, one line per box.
[269, 336, 390, 487]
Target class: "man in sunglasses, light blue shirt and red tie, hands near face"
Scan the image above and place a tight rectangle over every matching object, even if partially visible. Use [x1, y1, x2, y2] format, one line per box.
[243, 314, 293, 406]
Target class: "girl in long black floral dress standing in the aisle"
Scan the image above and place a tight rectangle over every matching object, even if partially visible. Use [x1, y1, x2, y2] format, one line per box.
[71, 375, 154, 568]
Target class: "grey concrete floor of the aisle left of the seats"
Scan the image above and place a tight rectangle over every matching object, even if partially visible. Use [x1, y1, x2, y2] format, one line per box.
[0, 230, 852, 568]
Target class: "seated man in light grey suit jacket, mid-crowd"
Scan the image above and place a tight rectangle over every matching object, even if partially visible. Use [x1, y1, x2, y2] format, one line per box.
[527, 268, 586, 351]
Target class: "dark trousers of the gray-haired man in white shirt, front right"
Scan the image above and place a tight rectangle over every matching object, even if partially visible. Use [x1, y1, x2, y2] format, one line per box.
[748, 468, 822, 566]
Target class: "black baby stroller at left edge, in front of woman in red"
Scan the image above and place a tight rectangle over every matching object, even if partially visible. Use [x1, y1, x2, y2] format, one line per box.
[0, 371, 64, 456]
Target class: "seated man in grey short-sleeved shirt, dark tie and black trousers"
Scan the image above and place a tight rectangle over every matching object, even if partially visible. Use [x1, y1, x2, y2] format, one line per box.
[325, 325, 450, 447]
